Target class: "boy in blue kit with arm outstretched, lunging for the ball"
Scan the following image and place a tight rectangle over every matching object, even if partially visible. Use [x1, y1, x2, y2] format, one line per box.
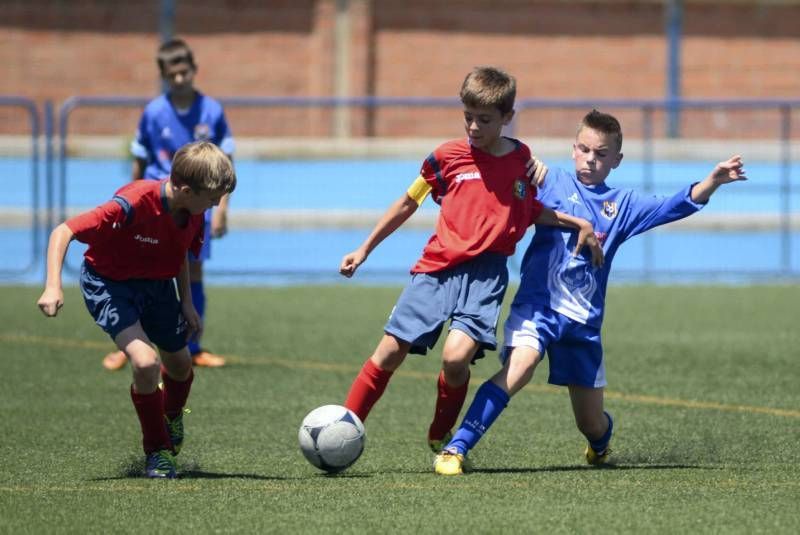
[434, 110, 746, 475]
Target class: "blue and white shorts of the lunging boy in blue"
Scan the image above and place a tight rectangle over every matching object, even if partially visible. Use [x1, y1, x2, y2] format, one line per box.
[500, 303, 606, 388]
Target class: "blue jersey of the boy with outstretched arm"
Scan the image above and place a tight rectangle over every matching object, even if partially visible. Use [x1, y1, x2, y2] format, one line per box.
[514, 169, 703, 328]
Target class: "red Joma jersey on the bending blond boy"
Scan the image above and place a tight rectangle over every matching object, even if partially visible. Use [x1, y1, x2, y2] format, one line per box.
[66, 180, 204, 281]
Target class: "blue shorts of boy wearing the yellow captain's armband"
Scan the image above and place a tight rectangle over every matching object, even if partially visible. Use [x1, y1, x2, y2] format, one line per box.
[384, 253, 508, 360]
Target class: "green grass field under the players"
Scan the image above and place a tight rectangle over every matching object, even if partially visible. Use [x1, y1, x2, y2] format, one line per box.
[0, 285, 800, 534]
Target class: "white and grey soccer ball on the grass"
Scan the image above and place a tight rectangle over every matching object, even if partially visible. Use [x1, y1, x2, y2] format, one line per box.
[297, 405, 367, 474]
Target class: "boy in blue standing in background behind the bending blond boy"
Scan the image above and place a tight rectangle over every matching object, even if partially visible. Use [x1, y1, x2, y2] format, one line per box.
[103, 39, 234, 370]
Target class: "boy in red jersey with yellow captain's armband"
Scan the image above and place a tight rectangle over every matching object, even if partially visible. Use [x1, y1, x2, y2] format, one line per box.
[339, 67, 603, 453]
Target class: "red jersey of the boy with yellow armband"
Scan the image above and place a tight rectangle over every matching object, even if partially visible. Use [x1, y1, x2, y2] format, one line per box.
[411, 139, 543, 273]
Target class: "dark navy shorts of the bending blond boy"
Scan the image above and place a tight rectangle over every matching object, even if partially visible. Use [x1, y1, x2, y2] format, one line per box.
[80, 262, 188, 353]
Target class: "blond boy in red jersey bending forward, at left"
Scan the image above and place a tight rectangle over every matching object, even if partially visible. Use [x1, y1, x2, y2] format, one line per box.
[37, 141, 236, 478]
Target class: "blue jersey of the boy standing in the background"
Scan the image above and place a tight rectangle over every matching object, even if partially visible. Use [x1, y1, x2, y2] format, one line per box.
[131, 92, 234, 180]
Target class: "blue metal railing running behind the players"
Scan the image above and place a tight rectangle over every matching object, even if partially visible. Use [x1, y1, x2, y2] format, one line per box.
[0, 96, 800, 280]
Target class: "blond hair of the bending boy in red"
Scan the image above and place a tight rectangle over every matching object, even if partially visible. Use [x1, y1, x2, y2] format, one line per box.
[170, 141, 236, 193]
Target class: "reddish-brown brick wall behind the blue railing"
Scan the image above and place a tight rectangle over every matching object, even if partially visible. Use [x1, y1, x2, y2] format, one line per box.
[0, 0, 800, 136]
